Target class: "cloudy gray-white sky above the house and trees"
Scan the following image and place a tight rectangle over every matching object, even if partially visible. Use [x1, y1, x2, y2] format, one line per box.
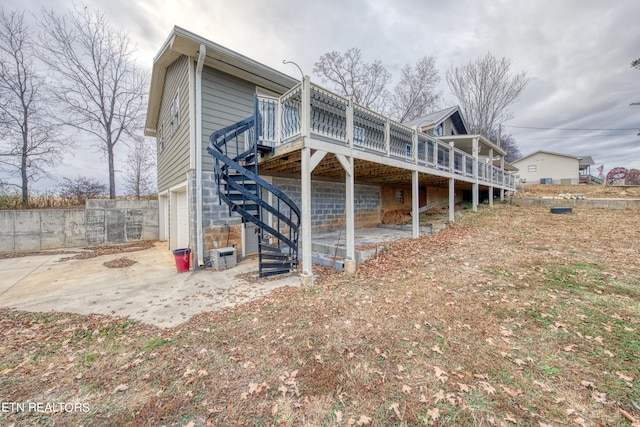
[3, 0, 640, 191]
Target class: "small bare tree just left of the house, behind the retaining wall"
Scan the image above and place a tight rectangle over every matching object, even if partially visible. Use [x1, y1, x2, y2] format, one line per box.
[124, 137, 156, 199]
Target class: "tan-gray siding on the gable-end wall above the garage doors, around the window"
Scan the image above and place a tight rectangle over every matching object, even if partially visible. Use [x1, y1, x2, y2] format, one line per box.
[156, 56, 190, 191]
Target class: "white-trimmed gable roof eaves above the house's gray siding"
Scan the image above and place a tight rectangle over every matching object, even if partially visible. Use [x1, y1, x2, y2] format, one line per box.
[145, 26, 299, 136]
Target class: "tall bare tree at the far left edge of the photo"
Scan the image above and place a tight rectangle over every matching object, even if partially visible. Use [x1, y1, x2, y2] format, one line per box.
[0, 9, 66, 208]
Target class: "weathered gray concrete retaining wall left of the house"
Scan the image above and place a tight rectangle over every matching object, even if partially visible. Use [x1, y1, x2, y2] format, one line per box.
[0, 200, 158, 252]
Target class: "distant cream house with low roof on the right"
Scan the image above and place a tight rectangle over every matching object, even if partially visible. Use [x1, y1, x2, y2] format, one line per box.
[513, 150, 594, 185]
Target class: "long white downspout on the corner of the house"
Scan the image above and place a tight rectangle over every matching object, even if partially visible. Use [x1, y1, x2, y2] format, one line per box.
[195, 44, 207, 267]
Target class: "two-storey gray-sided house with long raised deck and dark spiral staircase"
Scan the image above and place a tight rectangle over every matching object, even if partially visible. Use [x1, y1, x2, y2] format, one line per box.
[145, 27, 515, 283]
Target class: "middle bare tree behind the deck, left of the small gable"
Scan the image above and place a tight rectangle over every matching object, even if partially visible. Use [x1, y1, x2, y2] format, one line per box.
[387, 56, 441, 122]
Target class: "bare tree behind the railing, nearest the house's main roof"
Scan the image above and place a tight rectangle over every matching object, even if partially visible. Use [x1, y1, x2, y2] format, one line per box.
[313, 47, 391, 111]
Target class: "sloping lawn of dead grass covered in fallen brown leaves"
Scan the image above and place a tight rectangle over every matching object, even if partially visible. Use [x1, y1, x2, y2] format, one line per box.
[0, 205, 640, 427]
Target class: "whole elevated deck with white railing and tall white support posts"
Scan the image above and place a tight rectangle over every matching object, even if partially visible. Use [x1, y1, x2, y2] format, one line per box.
[250, 77, 515, 284]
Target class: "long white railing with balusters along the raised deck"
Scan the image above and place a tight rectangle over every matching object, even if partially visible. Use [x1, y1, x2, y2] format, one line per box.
[258, 79, 515, 189]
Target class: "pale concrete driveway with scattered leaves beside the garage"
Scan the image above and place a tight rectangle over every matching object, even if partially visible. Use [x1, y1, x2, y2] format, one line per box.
[0, 242, 300, 328]
